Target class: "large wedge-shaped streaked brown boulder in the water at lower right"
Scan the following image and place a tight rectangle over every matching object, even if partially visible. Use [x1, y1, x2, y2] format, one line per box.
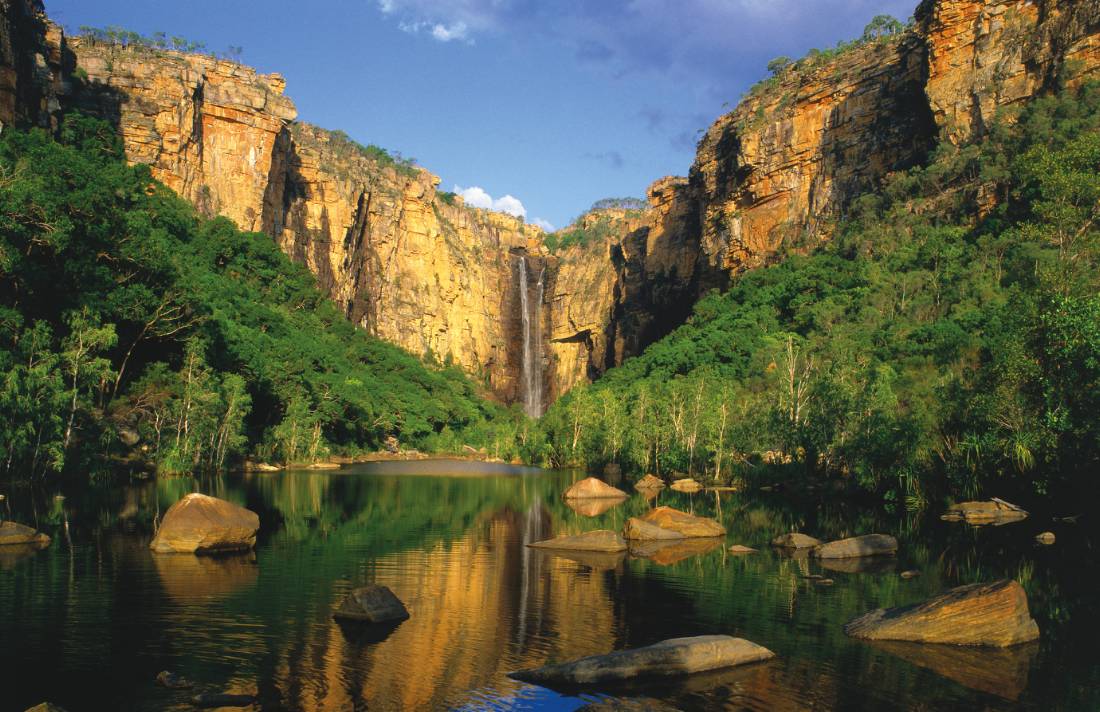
[844, 580, 1038, 647]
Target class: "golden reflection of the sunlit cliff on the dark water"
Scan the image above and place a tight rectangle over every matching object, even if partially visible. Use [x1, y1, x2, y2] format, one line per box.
[256, 503, 618, 710]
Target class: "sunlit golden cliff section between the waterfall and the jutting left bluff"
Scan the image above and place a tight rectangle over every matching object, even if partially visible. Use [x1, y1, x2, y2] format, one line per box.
[264, 119, 546, 402]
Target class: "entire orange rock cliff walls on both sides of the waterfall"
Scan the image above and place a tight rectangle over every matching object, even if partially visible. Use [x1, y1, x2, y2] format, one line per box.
[0, 0, 1100, 409]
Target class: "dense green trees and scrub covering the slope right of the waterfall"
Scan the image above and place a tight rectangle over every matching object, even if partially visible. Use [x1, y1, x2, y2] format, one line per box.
[543, 85, 1100, 505]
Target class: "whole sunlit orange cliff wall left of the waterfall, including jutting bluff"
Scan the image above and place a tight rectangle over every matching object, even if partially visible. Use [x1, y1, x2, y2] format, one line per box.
[70, 37, 551, 402]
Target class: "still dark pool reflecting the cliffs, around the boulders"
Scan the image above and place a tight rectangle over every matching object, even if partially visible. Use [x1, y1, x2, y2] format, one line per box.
[0, 461, 1100, 712]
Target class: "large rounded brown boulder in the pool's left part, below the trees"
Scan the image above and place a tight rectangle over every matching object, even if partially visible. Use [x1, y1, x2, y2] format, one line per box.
[149, 493, 260, 554]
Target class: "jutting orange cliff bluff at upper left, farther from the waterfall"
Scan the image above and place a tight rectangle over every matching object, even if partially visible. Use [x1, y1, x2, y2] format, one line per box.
[69, 37, 297, 230]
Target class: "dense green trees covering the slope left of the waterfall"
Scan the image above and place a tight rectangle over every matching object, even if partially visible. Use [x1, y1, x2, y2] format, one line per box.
[0, 116, 518, 477]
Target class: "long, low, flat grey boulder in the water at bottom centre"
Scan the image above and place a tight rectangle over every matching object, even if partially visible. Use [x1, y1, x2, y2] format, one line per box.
[508, 635, 776, 686]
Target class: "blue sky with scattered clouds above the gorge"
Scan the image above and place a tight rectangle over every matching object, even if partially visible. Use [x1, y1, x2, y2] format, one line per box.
[45, 0, 917, 227]
